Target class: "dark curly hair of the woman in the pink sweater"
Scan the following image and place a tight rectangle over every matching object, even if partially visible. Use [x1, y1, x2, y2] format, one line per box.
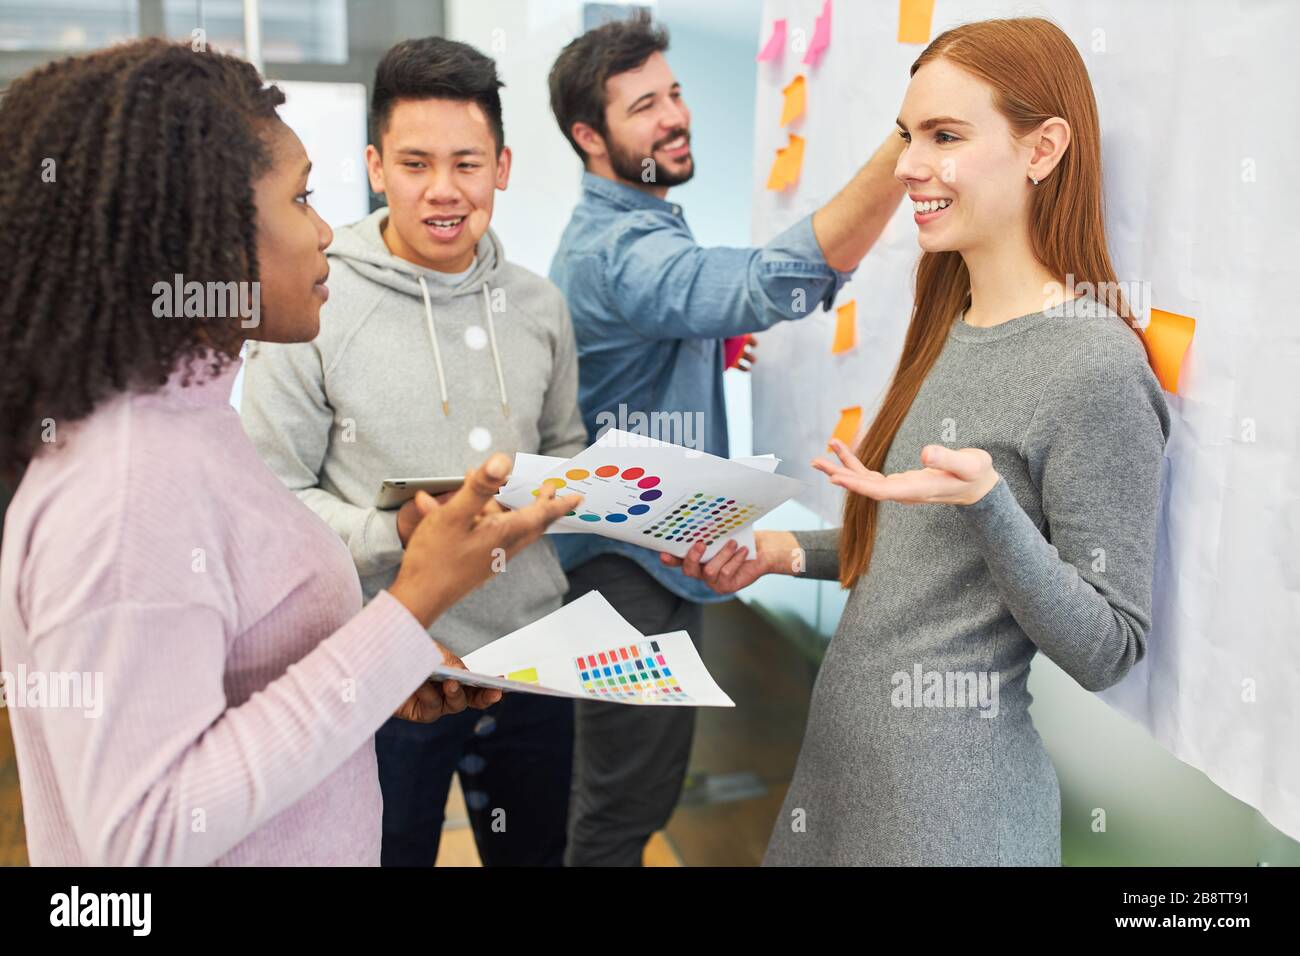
[0, 39, 285, 480]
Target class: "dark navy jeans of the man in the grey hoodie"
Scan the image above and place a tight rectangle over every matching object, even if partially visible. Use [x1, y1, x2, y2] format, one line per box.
[374, 693, 573, 866]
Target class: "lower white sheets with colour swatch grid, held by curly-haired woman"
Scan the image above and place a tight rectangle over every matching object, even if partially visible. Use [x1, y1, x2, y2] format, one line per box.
[430, 591, 736, 708]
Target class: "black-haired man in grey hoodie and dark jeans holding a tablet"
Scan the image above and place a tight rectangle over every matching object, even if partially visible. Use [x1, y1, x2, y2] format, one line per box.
[241, 38, 586, 866]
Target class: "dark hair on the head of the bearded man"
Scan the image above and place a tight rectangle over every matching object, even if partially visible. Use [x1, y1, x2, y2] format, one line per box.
[550, 10, 668, 164]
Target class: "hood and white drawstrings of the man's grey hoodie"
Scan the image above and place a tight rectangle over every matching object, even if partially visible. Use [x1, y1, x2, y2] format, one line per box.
[325, 207, 510, 418]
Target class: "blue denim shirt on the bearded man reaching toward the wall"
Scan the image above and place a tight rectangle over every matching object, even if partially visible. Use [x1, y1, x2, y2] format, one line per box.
[550, 173, 852, 604]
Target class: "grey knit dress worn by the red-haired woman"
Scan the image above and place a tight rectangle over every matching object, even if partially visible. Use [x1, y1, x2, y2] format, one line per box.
[763, 297, 1170, 866]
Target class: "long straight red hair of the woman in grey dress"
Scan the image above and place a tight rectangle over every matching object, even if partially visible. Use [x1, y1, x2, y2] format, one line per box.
[840, 17, 1131, 588]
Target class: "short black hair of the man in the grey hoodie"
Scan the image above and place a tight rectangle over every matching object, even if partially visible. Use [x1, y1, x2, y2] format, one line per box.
[371, 36, 506, 153]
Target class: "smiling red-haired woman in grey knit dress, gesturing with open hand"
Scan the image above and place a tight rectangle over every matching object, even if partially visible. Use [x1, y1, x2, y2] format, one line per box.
[666, 18, 1169, 865]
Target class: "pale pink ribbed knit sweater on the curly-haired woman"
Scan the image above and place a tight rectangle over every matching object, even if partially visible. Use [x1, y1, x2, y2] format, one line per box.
[0, 353, 442, 865]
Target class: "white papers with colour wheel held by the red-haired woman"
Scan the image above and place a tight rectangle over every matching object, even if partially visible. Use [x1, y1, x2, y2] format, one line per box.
[497, 428, 803, 561]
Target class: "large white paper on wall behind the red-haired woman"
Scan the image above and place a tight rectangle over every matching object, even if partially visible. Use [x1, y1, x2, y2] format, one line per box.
[753, 0, 1300, 839]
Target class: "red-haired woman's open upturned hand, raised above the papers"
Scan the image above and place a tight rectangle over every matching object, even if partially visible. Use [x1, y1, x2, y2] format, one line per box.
[813, 438, 1000, 505]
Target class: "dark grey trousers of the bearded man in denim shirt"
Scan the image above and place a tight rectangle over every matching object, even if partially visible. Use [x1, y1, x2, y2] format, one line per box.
[564, 554, 703, 866]
